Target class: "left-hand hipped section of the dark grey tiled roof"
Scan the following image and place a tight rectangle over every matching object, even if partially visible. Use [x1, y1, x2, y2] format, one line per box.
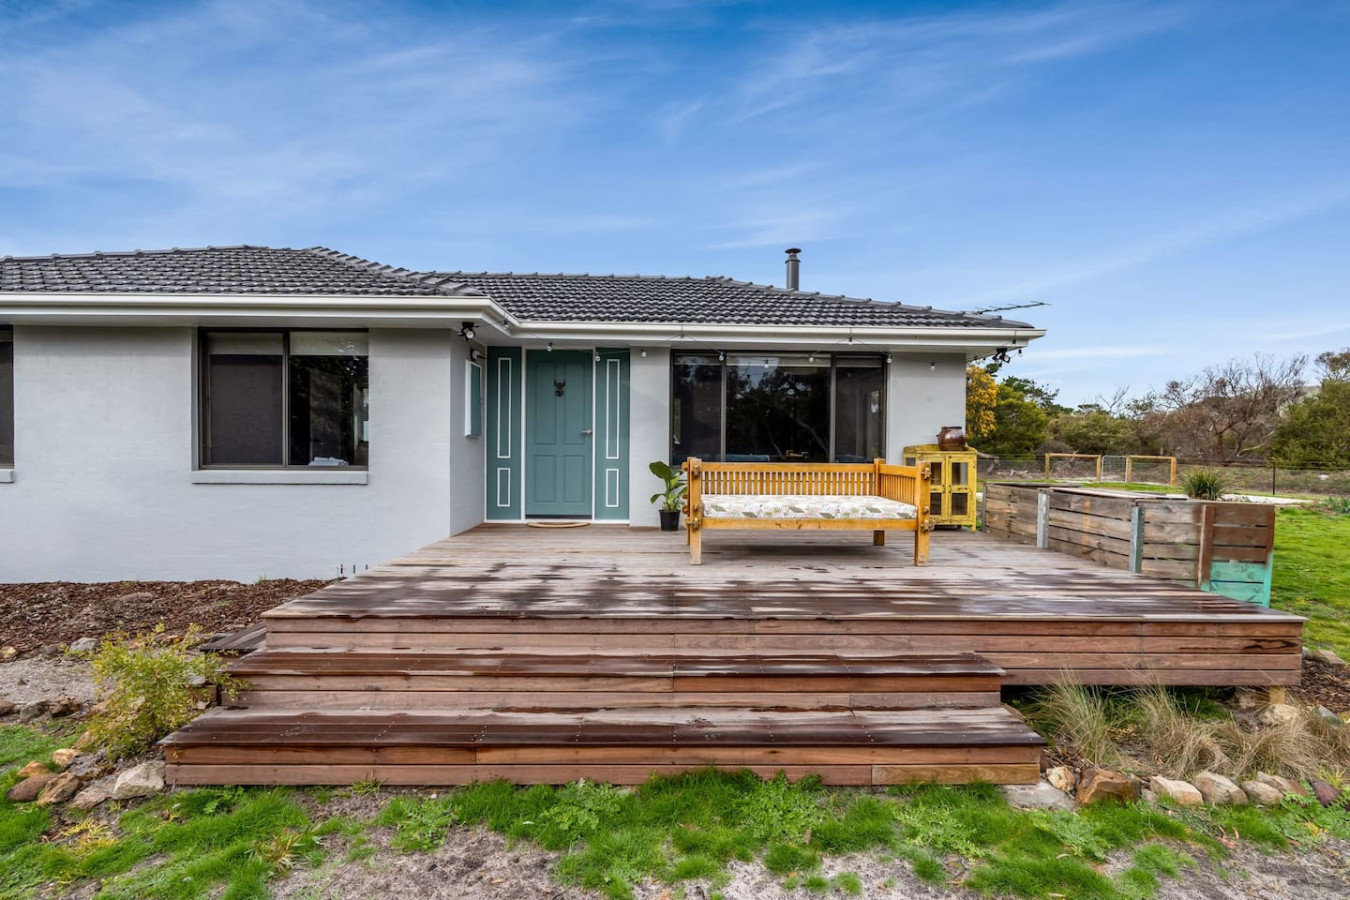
[0, 244, 483, 297]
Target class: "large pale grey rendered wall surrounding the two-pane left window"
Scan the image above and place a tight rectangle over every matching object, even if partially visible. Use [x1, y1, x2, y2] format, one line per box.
[0, 327, 483, 582]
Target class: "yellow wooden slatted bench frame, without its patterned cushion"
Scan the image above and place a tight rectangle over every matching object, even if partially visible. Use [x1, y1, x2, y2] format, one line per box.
[682, 456, 933, 565]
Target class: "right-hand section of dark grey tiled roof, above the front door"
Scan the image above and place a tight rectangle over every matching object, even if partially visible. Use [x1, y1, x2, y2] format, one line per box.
[436, 271, 1030, 329]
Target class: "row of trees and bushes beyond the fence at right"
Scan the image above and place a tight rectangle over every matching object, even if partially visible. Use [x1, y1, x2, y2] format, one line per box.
[965, 348, 1350, 468]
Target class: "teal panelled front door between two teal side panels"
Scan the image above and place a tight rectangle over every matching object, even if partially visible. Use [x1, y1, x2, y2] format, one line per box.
[525, 349, 594, 518]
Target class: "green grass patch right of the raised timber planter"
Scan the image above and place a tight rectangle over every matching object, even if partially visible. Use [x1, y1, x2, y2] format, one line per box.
[1270, 509, 1350, 658]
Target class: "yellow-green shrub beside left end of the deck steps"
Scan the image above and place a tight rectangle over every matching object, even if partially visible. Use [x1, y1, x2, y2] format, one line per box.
[89, 625, 242, 760]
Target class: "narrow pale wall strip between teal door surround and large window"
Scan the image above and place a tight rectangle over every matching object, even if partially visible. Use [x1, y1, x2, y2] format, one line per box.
[628, 347, 671, 528]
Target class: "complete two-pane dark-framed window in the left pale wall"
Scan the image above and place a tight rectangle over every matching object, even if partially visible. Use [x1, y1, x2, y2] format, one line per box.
[201, 331, 370, 468]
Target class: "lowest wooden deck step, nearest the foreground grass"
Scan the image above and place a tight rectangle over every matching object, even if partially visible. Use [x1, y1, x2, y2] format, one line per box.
[163, 707, 1042, 784]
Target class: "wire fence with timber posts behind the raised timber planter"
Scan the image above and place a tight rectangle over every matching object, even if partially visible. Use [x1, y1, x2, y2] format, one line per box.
[977, 455, 1350, 497]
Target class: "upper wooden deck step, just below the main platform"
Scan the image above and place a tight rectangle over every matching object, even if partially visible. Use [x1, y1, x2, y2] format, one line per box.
[231, 649, 1003, 710]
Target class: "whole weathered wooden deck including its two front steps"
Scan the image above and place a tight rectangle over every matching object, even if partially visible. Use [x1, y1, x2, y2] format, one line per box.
[166, 526, 1303, 784]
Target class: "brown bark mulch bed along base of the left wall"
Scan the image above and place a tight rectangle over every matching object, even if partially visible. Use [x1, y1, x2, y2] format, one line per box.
[0, 579, 332, 653]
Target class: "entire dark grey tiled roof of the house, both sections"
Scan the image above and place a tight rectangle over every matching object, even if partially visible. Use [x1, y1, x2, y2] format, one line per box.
[0, 244, 1030, 329]
